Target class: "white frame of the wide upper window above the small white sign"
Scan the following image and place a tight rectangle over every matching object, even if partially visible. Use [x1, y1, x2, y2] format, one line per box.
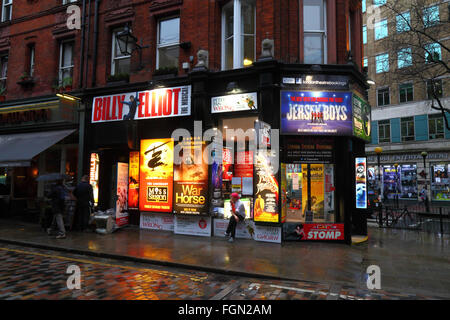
[221, 0, 256, 70]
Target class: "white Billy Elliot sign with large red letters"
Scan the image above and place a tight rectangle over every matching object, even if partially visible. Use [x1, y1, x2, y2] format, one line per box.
[91, 86, 191, 123]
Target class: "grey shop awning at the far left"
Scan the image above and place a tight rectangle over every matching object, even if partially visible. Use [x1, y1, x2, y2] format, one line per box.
[0, 129, 75, 167]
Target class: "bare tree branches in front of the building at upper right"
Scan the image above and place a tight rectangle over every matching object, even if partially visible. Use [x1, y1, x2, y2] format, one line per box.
[375, 0, 450, 130]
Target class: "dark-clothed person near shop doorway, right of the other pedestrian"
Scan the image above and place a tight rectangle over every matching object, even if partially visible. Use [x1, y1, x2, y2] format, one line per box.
[73, 175, 94, 231]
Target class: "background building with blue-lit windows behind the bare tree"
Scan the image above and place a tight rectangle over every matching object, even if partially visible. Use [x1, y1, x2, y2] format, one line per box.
[362, 0, 450, 204]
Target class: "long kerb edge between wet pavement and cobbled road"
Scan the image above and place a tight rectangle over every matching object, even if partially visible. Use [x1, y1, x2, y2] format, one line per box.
[0, 238, 302, 283]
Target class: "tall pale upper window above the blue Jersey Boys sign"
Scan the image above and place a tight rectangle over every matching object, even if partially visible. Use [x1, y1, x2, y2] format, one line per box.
[303, 0, 327, 64]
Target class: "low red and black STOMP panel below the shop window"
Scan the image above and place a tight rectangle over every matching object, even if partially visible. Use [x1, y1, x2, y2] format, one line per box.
[283, 223, 344, 241]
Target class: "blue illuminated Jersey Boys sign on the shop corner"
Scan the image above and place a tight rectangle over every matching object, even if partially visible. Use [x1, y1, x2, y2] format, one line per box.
[281, 91, 353, 136]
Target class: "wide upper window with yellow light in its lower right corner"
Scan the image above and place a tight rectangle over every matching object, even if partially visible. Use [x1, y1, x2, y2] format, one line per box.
[222, 0, 256, 70]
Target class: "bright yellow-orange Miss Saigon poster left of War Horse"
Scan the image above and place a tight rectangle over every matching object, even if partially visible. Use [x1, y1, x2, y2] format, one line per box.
[139, 138, 173, 212]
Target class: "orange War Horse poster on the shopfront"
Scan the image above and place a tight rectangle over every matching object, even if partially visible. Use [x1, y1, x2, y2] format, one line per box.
[173, 138, 208, 214]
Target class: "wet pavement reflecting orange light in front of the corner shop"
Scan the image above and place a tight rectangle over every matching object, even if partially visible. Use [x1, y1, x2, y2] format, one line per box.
[0, 220, 450, 299]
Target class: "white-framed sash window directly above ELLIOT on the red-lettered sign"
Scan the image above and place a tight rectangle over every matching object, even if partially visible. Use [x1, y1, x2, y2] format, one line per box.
[156, 17, 180, 69]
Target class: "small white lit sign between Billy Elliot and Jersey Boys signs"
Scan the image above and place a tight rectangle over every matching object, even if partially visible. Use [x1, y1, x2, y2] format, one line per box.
[211, 92, 258, 113]
